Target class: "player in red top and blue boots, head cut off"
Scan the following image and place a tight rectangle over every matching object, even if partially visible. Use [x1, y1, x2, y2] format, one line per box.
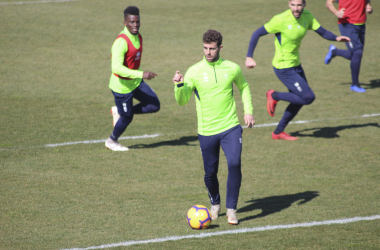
[325, 0, 372, 92]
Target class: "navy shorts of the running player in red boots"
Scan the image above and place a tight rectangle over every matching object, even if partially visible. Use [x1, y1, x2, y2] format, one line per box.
[273, 65, 311, 97]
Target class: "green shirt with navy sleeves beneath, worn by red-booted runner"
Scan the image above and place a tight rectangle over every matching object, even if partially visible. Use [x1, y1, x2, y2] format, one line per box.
[264, 9, 321, 69]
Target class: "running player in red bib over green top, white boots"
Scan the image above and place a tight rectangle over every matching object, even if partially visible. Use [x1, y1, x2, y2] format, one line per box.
[105, 6, 160, 151]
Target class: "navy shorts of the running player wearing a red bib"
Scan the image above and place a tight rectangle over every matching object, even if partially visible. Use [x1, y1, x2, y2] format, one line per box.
[112, 81, 160, 116]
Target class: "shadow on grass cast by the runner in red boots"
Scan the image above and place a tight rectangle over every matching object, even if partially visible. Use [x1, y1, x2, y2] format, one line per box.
[290, 123, 380, 139]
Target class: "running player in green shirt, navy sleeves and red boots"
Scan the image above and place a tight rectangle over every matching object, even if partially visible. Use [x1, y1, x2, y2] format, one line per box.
[245, 0, 350, 140]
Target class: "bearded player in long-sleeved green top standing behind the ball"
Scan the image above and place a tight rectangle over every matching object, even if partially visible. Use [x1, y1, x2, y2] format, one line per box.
[173, 30, 255, 225]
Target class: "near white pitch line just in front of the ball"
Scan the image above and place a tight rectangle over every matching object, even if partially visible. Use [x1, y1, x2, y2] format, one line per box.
[63, 215, 380, 250]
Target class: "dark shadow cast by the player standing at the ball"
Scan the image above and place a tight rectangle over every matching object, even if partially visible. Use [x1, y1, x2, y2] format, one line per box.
[237, 191, 319, 222]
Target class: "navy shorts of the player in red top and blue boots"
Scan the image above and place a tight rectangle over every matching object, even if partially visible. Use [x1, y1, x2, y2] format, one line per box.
[339, 23, 365, 52]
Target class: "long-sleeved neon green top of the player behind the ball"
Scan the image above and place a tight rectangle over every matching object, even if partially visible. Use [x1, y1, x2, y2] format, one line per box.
[174, 58, 253, 136]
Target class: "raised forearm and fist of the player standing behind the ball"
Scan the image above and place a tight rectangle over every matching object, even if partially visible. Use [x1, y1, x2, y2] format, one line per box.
[173, 70, 194, 106]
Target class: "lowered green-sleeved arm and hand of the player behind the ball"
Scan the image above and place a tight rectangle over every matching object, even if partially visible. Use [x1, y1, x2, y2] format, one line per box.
[234, 65, 255, 128]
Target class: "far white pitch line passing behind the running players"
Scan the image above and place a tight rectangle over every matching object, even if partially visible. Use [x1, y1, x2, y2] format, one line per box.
[0, 114, 380, 151]
